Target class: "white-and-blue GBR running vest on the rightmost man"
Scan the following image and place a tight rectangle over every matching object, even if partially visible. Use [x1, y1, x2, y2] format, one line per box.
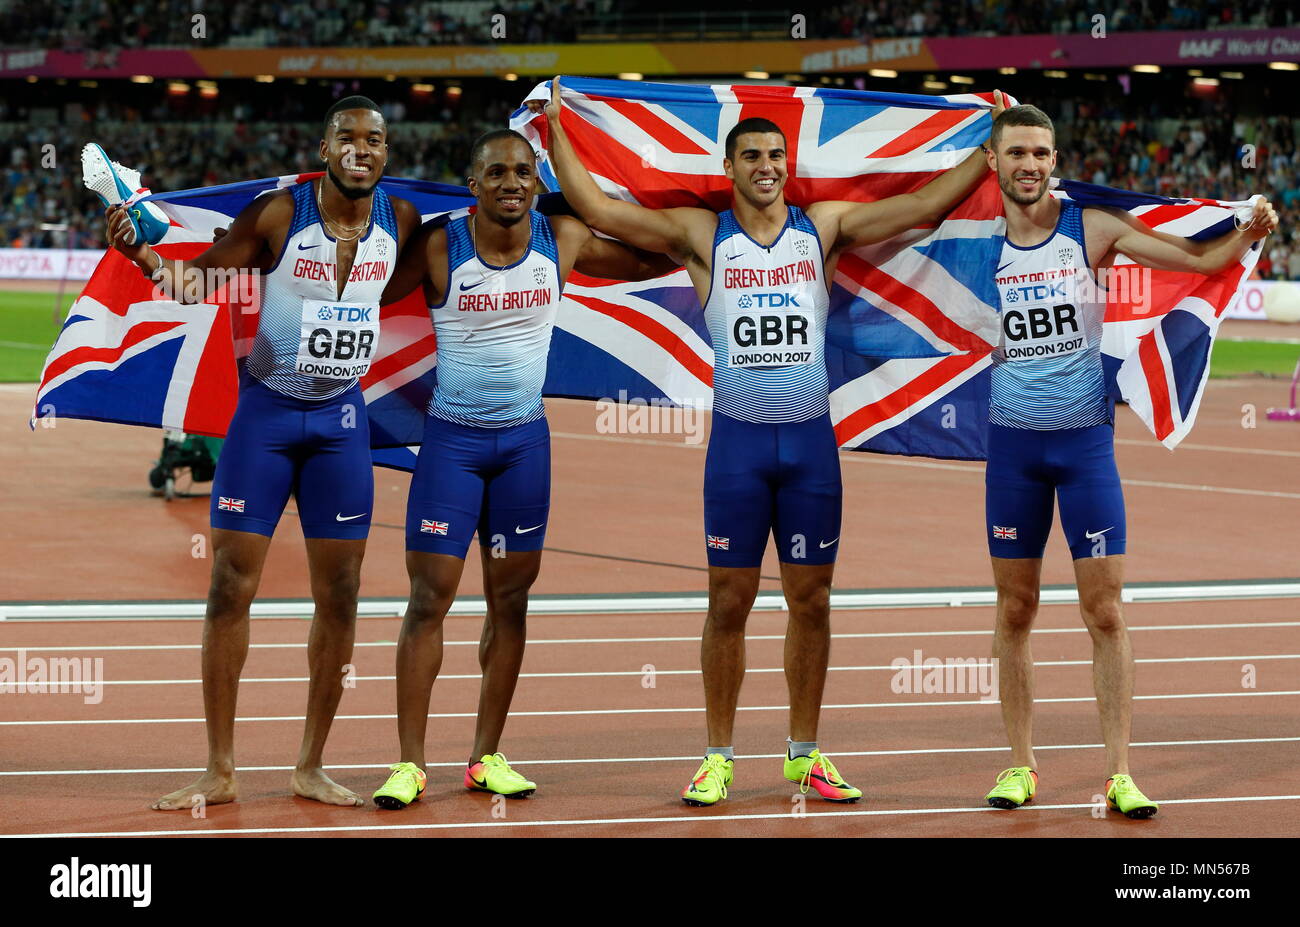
[988, 200, 1110, 432]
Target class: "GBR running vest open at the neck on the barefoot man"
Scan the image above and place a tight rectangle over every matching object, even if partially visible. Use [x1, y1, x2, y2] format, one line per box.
[246, 183, 398, 399]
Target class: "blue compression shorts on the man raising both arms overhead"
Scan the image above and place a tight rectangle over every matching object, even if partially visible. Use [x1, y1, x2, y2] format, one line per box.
[705, 411, 844, 567]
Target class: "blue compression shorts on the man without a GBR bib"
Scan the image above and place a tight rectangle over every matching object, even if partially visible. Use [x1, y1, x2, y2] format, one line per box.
[407, 415, 551, 559]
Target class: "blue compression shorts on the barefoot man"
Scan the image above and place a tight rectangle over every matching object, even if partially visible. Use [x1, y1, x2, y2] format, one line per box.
[211, 374, 374, 541]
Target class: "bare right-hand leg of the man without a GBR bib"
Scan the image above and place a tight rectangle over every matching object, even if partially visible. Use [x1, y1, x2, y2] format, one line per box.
[469, 546, 542, 763]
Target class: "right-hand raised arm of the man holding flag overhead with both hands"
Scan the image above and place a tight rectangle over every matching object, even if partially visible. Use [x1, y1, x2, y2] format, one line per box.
[807, 90, 1006, 251]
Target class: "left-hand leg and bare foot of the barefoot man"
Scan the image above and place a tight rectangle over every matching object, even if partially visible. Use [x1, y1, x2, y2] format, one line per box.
[151, 528, 270, 811]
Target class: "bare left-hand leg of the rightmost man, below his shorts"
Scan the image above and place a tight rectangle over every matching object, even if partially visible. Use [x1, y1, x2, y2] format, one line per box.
[992, 556, 1043, 770]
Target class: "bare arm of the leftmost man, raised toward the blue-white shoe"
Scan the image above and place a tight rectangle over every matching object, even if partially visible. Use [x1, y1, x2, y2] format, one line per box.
[105, 192, 294, 303]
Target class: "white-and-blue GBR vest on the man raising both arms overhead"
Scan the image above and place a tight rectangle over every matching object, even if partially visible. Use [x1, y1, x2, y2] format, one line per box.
[705, 205, 831, 423]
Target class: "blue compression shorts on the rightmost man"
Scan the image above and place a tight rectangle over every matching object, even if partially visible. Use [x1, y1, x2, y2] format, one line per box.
[984, 424, 1127, 560]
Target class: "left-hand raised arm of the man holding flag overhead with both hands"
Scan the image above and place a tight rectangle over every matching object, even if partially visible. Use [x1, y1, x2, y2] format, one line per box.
[546, 77, 718, 263]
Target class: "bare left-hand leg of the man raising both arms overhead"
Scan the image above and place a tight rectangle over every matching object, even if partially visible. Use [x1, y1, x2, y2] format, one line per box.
[699, 567, 761, 746]
